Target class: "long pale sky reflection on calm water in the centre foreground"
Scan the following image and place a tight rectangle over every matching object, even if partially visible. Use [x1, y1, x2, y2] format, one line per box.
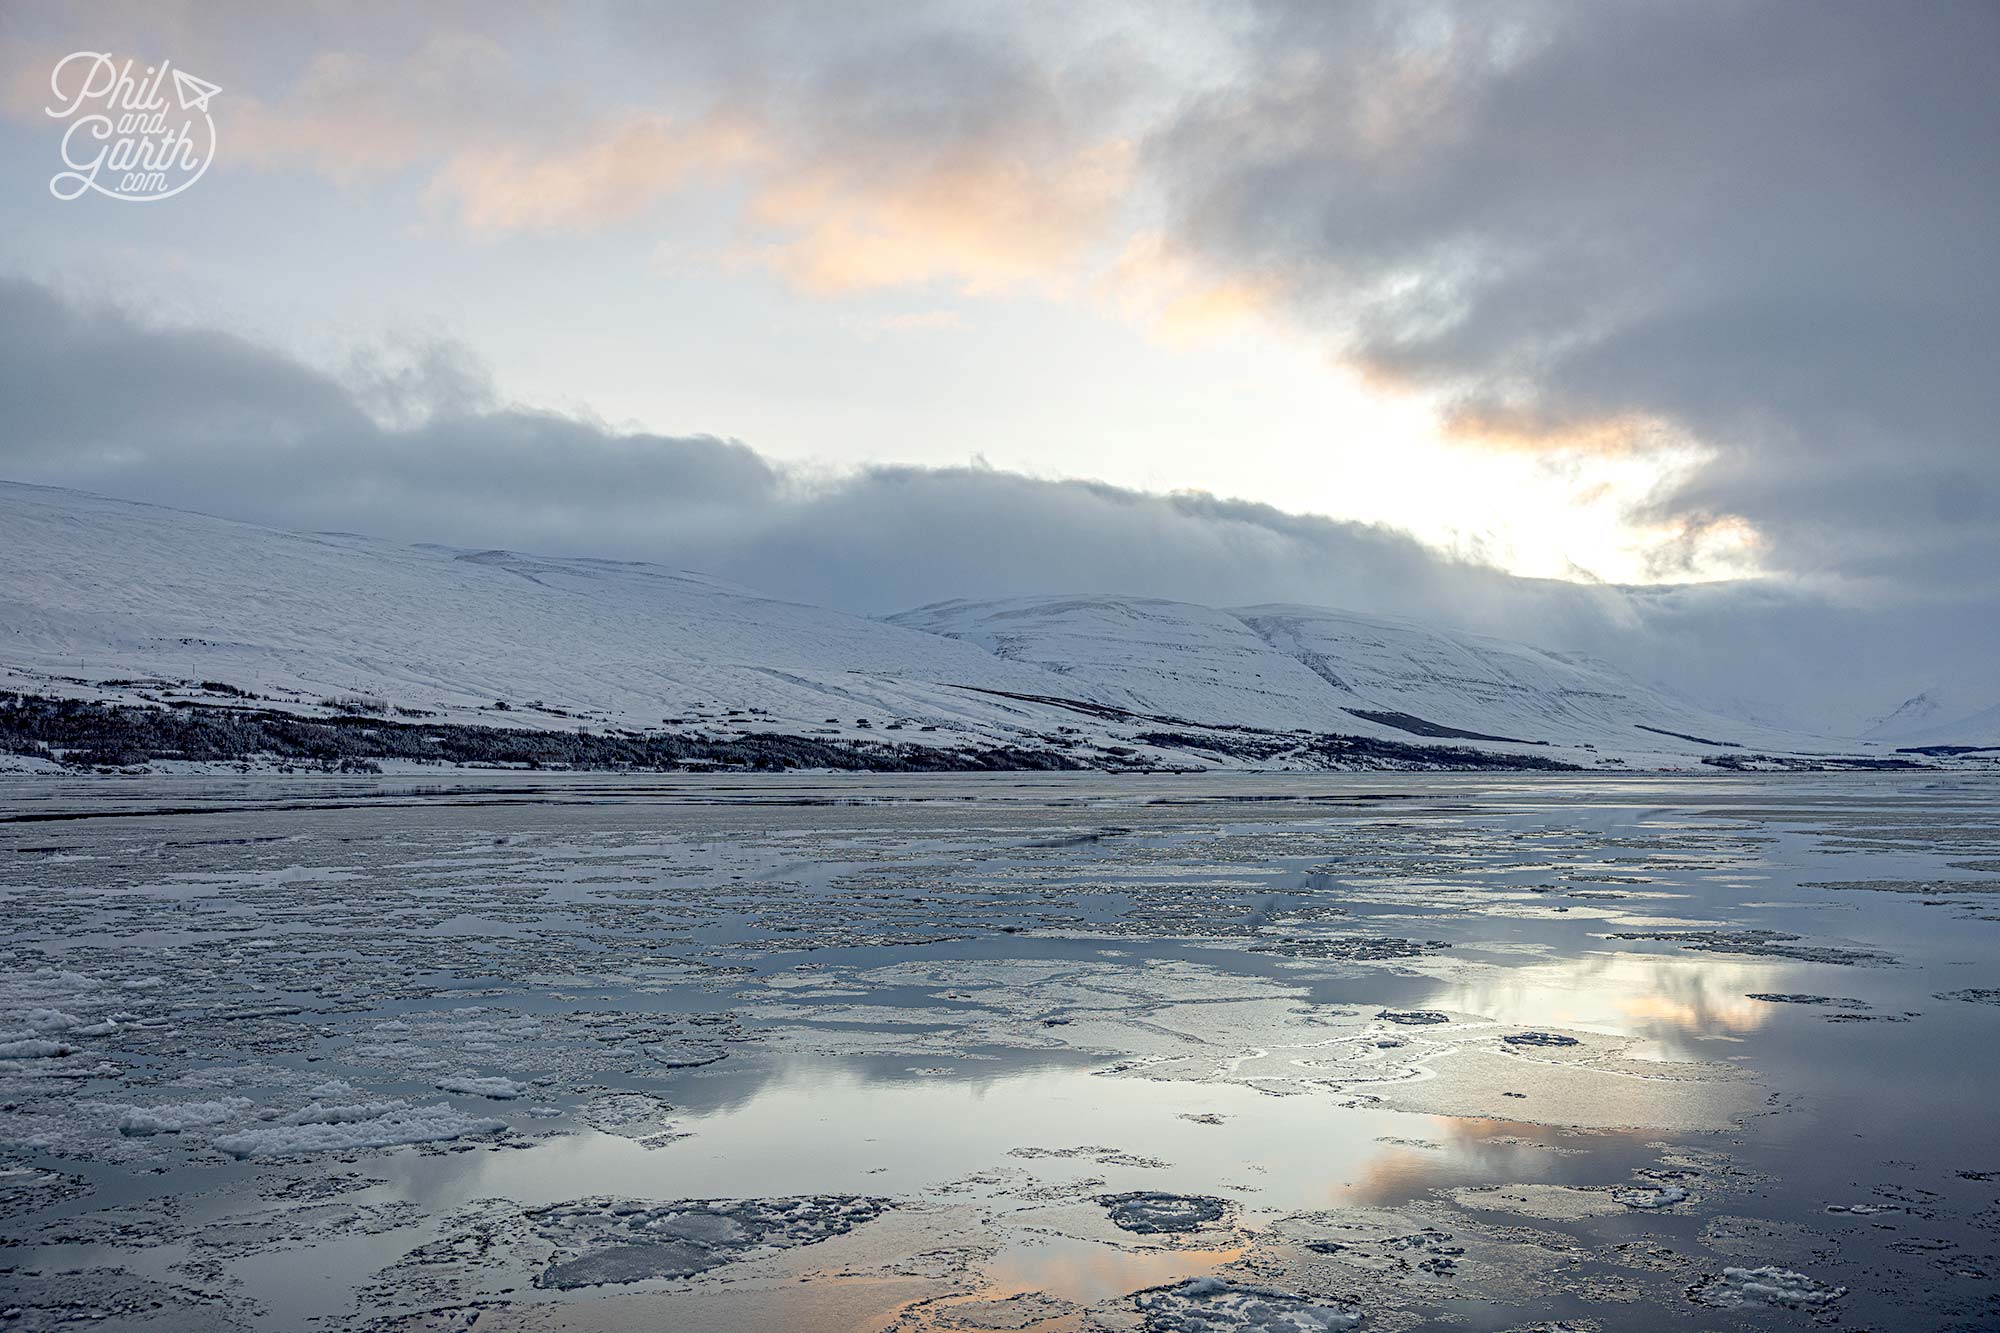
[426, 1063, 1430, 1209]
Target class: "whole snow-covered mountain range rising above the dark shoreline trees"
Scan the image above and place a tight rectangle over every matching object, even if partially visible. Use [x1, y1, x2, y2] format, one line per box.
[0, 482, 1904, 767]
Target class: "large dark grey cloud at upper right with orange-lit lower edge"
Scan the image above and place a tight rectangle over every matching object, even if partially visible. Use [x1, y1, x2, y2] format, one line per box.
[1148, 2, 2000, 592]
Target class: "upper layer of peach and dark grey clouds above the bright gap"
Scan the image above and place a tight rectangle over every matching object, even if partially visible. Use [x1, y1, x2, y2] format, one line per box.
[141, 0, 2000, 590]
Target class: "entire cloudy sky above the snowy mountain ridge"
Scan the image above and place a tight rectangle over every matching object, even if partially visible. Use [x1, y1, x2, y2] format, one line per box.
[0, 0, 2000, 721]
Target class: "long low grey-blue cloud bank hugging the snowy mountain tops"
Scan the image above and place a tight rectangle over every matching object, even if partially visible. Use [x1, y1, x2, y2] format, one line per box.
[0, 280, 2000, 719]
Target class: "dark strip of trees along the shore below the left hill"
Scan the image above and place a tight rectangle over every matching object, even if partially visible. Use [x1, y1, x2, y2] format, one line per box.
[0, 691, 1082, 773]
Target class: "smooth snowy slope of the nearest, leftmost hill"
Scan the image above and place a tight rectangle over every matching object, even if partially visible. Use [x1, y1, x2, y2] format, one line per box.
[0, 484, 1088, 727]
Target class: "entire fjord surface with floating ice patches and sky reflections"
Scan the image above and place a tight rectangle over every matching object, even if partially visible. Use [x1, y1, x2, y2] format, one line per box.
[0, 775, 2000, 1333]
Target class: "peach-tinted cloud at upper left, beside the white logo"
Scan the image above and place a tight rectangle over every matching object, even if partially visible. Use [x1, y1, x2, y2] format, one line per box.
[0, 4, 1134, 296]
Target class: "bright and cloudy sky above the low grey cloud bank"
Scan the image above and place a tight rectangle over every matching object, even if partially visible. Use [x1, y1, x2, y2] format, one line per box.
[0, 2, 2000, 728]
